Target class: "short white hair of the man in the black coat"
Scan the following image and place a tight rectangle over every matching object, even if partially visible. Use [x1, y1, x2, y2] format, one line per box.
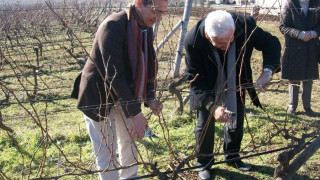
[204, 10, 235, 39]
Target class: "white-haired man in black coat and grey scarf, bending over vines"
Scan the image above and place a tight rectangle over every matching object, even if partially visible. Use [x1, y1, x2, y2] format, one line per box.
[185, 11, 281, 179]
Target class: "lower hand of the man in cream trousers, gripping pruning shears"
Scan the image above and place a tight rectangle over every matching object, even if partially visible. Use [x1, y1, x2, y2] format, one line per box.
[129, 113, 148, 139]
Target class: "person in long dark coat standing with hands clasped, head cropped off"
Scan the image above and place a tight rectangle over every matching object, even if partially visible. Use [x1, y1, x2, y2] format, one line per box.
[280, 0, 320, 116]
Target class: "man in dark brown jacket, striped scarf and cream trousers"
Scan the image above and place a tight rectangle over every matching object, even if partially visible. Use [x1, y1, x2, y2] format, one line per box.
[74, 0, 168, 180]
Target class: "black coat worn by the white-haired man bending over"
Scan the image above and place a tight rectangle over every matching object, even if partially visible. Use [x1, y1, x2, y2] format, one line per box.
[185, 13, 281, 110]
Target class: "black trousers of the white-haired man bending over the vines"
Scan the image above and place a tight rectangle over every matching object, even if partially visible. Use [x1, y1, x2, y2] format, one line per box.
[195, 93, 245, 165]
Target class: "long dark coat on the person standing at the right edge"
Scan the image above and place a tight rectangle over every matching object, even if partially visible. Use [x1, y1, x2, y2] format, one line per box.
[280, 0, 320, 80]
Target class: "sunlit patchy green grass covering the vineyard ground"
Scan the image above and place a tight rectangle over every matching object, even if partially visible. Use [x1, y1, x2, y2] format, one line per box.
[0, 8, 320, 180]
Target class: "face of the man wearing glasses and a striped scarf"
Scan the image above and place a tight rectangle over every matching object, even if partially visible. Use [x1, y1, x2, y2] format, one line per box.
[137, 0, 168, 27]
